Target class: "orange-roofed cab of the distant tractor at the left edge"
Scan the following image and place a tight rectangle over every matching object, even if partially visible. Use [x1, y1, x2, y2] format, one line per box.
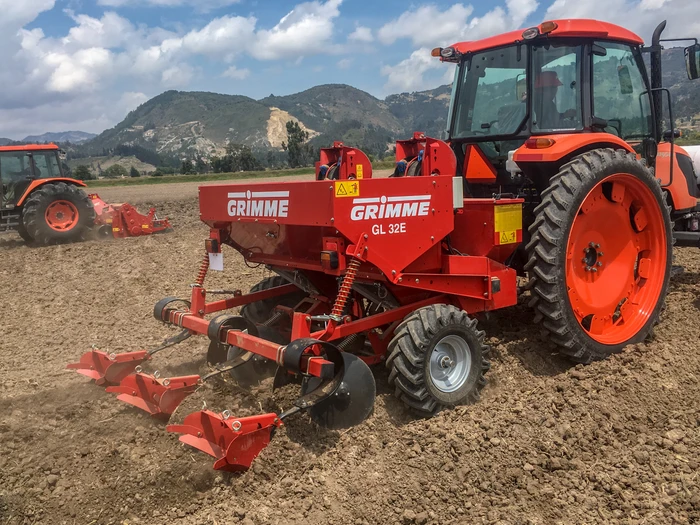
[0, 144, 63, 209]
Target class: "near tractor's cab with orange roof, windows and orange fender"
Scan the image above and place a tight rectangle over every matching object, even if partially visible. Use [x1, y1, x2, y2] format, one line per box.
[432, 20, 700, 208]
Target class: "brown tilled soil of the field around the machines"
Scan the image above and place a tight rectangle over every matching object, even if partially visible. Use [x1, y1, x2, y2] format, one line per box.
[0, 179, 700, 525]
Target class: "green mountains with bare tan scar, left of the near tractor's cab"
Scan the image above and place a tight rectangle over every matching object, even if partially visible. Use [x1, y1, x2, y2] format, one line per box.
[82, 84, 449, 157]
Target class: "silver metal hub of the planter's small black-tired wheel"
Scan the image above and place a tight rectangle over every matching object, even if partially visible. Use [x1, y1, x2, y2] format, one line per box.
[430, 335, 472, 393]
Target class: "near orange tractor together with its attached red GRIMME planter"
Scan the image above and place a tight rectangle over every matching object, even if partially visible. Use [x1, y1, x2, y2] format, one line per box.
[69, 20, 700, 470]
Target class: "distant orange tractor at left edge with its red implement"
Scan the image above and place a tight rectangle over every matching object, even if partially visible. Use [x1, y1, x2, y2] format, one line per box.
[0, 144, 170, 244]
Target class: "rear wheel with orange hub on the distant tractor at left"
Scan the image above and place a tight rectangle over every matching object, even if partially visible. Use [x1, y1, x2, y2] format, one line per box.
[22, 182, 95, 244]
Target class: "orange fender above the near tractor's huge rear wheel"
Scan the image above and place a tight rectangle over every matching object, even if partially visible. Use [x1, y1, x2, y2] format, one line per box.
[513, 133, 634, 164]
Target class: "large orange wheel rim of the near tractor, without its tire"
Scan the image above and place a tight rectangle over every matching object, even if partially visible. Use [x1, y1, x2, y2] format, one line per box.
[566, 173, 668, 345]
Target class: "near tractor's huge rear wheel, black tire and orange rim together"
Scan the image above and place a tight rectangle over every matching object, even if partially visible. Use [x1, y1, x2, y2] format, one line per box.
[526, 149, 673, 363]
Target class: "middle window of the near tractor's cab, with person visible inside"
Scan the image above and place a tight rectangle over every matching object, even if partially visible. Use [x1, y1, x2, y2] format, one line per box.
[531, 43, 583, 131]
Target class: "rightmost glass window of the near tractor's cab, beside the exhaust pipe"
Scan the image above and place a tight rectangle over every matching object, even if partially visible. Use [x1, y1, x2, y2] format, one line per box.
[593, 42, 653, 141]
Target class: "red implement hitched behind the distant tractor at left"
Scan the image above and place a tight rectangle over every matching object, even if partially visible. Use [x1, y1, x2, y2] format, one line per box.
[89, 193, 171, 239]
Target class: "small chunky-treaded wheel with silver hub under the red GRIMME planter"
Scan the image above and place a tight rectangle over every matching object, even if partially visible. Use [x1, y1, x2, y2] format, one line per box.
[386, 304, 491, 416]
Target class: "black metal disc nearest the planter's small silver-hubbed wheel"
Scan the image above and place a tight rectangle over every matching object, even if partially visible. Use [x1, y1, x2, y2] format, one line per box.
[301, 353, 377, 430]
